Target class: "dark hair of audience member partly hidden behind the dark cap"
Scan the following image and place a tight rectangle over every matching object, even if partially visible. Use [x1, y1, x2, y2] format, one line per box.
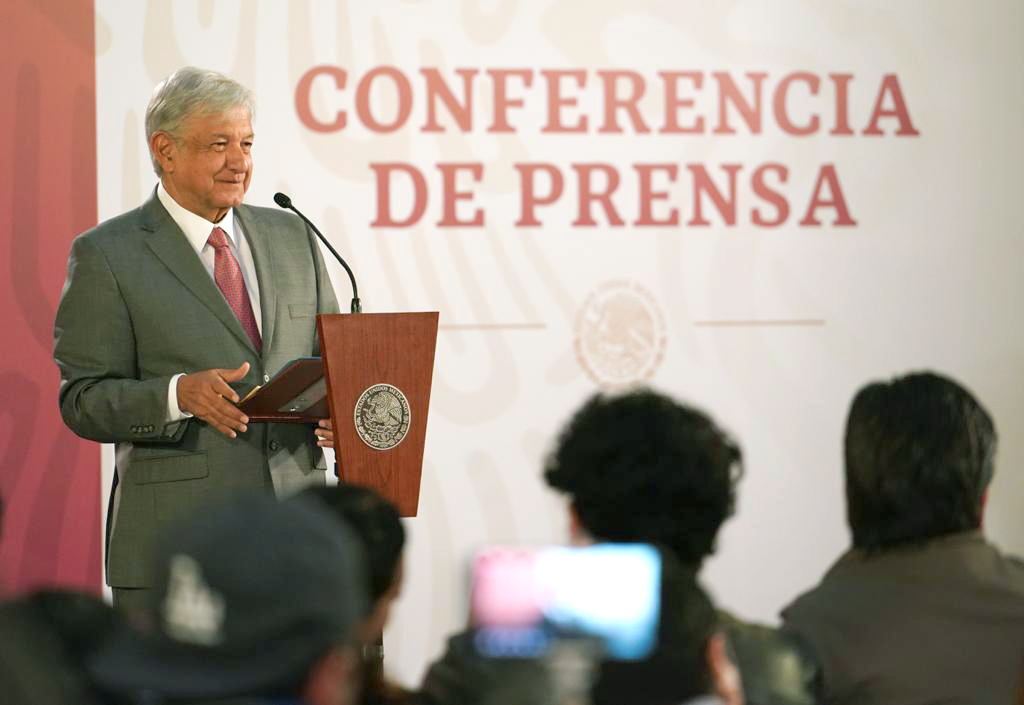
[304, 485, 406, 603]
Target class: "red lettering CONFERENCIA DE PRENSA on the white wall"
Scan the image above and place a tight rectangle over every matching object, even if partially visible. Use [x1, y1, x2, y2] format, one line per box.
[295, 66, 920, 227]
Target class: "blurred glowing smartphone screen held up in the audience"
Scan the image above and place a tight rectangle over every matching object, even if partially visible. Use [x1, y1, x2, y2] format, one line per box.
[470, 543, 662, 660]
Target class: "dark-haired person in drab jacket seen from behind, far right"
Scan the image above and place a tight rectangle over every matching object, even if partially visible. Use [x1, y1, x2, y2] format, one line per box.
[782, 373, 1024, 705]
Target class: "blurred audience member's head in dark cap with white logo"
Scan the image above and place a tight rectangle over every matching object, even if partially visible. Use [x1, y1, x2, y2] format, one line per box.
[91, 496, 367, 705]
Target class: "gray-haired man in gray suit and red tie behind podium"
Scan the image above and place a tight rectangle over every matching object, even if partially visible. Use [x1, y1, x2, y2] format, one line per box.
[54, 68, 338, 606]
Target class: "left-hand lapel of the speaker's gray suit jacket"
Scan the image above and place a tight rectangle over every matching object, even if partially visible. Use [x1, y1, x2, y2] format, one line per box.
[141, 192, 263, 357]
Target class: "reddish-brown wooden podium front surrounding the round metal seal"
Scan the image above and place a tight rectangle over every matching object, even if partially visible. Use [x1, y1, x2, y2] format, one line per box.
[316, 312, 437, 516]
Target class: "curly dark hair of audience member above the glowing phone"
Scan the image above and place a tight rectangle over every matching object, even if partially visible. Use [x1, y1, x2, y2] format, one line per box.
[544, 389, 742, 567]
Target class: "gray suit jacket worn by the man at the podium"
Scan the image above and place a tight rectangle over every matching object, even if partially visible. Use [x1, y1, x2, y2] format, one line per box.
[54, 193, 338, 587]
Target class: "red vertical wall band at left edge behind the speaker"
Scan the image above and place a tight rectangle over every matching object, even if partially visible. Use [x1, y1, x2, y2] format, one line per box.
[0, 0, 102, 593]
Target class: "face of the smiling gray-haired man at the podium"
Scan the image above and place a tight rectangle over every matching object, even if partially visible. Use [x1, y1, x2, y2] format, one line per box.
[158, 107, 253, 222]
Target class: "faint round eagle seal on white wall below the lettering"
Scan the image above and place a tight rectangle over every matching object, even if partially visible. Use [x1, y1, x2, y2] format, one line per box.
[575, 281, 666, 388]
